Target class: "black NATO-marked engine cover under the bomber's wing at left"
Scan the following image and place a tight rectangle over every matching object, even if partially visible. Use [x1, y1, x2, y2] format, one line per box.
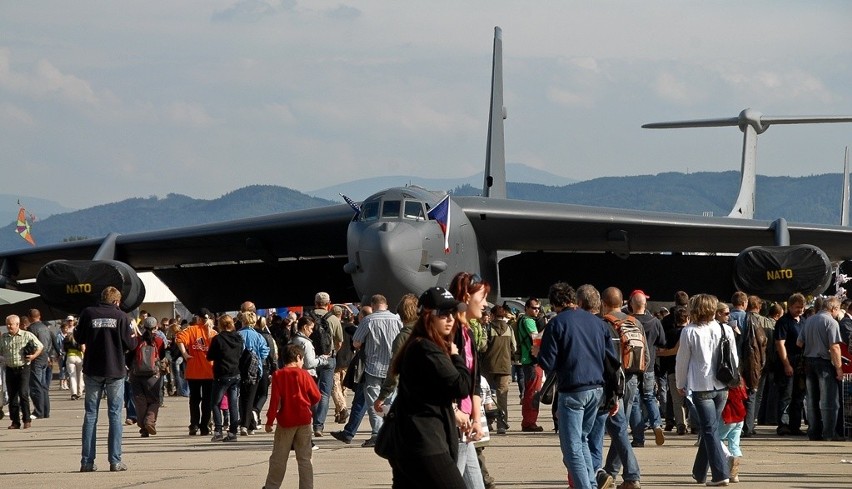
[36, 260, 145, 312]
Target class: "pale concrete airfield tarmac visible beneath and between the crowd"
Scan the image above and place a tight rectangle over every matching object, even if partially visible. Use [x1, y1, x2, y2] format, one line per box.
[0, 382, 852, 489]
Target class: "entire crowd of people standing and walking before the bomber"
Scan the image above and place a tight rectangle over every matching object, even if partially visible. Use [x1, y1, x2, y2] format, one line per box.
[0, 273, 852, 489]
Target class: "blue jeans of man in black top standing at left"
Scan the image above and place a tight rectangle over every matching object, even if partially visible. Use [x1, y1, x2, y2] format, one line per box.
[80, 374, 124, 466]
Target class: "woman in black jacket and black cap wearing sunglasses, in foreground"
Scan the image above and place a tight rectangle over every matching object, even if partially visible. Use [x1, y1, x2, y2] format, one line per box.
[384, 287, 473, 489]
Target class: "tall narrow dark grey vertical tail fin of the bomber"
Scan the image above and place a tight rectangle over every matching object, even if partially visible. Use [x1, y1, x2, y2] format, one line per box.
[482, 27, 506, 199]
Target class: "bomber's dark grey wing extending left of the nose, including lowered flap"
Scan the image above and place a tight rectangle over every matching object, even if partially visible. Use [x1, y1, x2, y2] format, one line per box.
[0, 204, 356, 311]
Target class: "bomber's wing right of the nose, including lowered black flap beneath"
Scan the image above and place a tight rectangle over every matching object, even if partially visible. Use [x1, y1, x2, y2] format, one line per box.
[453, 197, 852, 300]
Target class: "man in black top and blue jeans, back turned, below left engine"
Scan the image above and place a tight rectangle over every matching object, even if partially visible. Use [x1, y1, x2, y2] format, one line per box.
[74, 286, 136, 472]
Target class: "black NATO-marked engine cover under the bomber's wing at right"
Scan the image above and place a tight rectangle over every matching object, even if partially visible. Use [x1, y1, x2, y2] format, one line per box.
[734, 245, 832, 300]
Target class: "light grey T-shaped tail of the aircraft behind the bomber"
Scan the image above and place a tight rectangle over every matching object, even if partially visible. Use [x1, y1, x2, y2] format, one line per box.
[642, 109, 852, 219]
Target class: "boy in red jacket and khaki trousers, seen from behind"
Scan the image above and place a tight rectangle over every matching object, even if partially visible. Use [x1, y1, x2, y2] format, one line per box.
[263, 345, 320, 489]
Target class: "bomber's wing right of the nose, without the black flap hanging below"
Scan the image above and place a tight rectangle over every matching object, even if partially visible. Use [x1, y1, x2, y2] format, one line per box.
[460, 197, 852, 260]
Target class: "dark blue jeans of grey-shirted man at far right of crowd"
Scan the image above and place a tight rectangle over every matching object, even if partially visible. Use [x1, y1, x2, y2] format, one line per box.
[805, 357, 840, 440]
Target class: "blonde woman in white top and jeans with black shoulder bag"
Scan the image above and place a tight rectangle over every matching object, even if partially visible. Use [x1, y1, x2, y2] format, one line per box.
[675, 294, 737, 486]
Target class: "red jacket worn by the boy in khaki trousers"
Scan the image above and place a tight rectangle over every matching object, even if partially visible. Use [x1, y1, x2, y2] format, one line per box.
[266, 367, 320, 428]
